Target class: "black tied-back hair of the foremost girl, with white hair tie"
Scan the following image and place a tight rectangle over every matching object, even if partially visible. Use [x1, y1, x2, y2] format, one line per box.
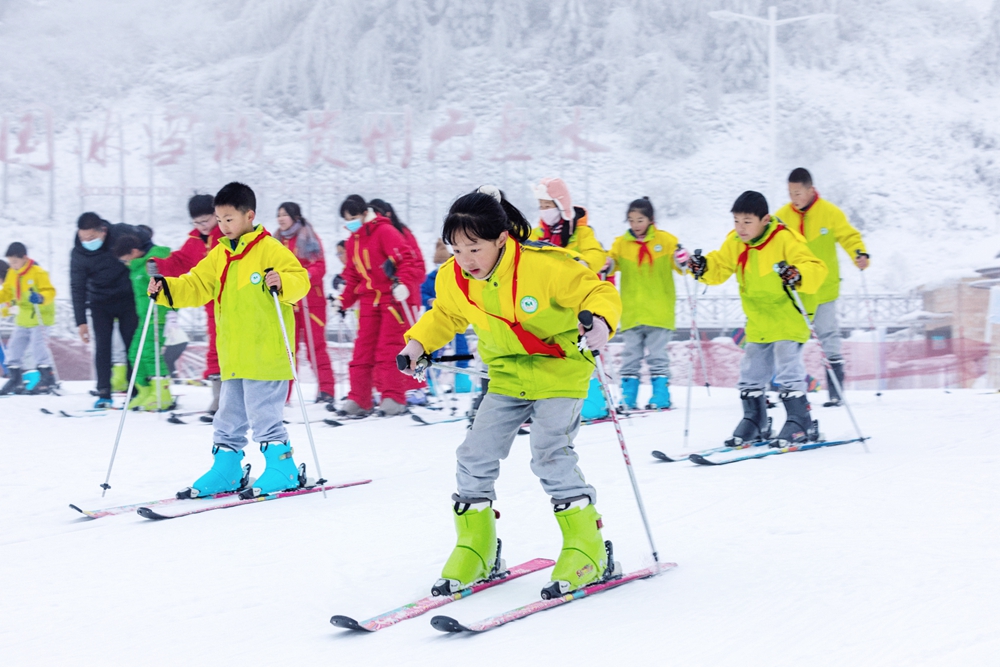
[441, 185, 531, 245]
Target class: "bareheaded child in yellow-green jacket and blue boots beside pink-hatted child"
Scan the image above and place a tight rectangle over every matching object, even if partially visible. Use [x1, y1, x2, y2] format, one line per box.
[606, 197, 686, 410]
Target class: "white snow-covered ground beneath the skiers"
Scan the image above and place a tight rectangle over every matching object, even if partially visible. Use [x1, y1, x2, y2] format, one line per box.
[0, 383, 1000, 667]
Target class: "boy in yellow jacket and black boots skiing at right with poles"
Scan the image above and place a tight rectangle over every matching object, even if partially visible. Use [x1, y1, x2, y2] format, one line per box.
[689, 190, 826, 447]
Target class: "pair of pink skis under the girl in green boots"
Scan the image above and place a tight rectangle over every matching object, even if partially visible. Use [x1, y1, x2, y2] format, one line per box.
[330, 558, 677, 633]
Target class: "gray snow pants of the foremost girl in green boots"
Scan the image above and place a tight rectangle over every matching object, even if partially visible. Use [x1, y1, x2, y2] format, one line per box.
[455, 394, 597, 503]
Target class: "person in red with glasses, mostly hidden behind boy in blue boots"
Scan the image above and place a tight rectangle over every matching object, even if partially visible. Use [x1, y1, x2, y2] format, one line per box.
[153, 195, 222, 422]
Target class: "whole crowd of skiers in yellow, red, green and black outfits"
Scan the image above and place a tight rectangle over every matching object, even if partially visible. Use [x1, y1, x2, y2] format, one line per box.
[0, 168, 868, 596]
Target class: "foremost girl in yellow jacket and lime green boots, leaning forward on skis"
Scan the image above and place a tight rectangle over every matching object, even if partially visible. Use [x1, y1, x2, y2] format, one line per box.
[402, 186, 621, 596]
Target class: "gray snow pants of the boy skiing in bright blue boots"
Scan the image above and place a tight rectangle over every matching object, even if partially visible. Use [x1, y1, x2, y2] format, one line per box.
[212, 380, 288, 451]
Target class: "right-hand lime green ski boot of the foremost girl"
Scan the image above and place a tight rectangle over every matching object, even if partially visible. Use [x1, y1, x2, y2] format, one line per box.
[542, 496, 621, 600]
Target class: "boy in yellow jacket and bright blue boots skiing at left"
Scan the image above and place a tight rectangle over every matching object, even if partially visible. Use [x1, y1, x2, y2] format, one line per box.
[149, 183, 309, 498]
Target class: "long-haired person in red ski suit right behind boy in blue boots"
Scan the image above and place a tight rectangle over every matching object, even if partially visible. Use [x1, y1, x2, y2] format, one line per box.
[277, 201, 335, 403]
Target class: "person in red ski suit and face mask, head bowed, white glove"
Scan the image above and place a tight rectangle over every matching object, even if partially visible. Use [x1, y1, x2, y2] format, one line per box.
[337, 195, 424, 418]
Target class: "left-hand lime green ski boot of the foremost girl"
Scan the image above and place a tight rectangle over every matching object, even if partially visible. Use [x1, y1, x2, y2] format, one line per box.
[431, 494, 507, 595]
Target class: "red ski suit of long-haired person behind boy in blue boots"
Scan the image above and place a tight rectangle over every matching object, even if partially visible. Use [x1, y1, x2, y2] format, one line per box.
[275, 224, 334, 396]
